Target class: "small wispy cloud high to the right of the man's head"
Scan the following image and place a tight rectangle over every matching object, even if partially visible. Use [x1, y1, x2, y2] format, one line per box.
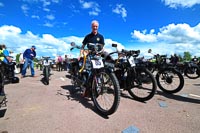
[112, 4, 127, 21]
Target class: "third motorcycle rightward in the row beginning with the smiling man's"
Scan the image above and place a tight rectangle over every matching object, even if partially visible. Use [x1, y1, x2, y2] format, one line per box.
[147, 49, 184, 94]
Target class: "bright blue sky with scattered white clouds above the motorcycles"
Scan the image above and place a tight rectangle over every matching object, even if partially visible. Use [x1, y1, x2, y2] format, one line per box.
[0, 0, 200, 57]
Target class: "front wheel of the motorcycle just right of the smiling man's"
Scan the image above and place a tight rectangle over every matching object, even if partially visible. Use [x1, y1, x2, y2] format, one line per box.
[128, 69, 157, 102]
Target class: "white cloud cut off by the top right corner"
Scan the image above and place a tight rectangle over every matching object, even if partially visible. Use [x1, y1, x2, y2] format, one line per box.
[162, 0, 200, 9]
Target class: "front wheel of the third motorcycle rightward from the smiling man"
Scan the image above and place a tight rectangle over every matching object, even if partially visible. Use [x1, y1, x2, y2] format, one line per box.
[156, 69, 184, 94]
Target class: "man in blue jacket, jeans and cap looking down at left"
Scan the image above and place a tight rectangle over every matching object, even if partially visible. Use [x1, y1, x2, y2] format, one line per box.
[22, 46, 36, 78]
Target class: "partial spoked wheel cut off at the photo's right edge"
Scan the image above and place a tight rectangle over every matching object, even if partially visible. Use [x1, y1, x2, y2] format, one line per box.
[185, 66, 200, 79]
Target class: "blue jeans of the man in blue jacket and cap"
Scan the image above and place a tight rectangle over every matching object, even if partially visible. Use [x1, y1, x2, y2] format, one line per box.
[22, 58, 35, 76]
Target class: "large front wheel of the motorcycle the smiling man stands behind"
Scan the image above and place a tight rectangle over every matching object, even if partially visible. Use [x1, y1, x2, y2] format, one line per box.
[92, 71, 120, 115]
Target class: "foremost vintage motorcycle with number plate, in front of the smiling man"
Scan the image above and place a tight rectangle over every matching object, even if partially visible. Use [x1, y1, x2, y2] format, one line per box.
[70, 43, 120, 115]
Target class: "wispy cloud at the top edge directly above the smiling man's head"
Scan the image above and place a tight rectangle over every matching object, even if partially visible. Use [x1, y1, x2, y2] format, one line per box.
[79, 0, 101, 16]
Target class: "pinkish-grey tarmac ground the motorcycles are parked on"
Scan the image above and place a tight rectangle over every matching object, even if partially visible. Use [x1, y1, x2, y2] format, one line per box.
[0, 69, 200, 133]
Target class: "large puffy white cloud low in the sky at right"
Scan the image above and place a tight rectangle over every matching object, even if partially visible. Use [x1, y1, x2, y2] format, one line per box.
[131, 23, 200, 56]
